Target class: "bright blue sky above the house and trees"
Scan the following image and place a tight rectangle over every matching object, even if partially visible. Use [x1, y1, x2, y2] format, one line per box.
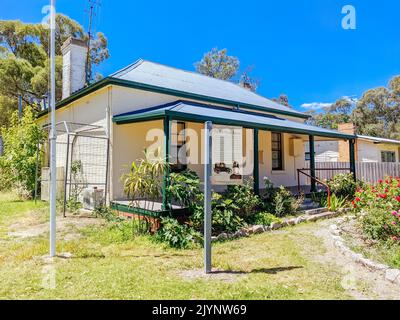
[0, 0, 400, 110]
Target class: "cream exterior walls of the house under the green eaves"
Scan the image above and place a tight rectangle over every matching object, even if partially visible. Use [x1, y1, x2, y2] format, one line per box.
[39, 86, 310, 199]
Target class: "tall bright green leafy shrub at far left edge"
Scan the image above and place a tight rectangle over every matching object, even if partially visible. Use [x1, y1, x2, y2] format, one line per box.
[0, 109, 43, 197]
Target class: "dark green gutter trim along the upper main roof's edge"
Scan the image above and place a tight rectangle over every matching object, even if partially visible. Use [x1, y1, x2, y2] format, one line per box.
[38, 77, 310, 119]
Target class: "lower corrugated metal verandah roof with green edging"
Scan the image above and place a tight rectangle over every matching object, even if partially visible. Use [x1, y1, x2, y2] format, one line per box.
[113, 100, 355, 139]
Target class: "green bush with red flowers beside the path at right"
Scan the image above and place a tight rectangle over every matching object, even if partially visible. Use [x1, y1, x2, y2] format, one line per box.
[352, 177, 400, 242]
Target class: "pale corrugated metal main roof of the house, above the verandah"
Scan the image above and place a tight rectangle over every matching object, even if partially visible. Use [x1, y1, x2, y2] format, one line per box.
[110, 59, 307, 117]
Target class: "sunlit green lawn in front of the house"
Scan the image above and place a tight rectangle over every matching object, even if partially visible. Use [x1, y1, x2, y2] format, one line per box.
[0, 194, 350, 299]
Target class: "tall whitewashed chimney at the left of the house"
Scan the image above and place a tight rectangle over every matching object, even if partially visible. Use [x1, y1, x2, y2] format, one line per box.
[61, 37, 88, 99]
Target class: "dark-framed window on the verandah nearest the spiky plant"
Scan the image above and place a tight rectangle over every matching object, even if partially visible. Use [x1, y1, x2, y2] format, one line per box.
[171, 121, 187, 172]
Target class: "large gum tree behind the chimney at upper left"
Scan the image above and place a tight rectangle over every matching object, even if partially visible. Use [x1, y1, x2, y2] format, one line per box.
[0, 14, 109, 126]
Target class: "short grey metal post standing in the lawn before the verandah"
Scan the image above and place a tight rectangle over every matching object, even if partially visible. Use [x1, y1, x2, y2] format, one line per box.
[204, 121, 212, 273]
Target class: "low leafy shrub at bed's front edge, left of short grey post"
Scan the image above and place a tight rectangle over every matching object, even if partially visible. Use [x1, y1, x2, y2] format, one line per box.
[156, 218, 201, 249]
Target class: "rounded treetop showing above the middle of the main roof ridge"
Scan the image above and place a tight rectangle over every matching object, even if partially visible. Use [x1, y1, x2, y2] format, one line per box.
[195, 48, 239, 80]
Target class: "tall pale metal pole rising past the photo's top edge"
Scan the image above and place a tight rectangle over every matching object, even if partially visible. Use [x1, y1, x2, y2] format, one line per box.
[50, 0, 57, 257]
